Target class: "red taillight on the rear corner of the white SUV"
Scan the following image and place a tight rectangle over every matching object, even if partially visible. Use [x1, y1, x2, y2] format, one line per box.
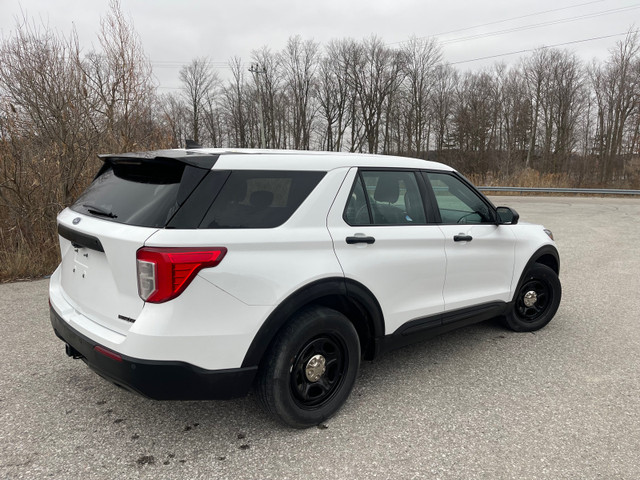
[136, 247, 227, 303]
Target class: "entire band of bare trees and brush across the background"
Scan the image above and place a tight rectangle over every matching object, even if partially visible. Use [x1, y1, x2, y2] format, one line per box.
[0, 0, 640, 279]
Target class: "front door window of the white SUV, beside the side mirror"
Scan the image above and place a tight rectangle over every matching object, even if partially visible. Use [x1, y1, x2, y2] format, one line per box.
[426, 172, 494, 224]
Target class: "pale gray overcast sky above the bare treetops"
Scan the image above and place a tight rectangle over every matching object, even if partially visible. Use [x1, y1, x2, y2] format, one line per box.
[0, 0, 640, 89]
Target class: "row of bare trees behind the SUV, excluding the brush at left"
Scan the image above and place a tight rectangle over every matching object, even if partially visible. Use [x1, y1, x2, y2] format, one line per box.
[170, 32, 640, 186]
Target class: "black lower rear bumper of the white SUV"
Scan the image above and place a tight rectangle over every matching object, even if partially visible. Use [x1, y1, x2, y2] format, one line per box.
[50, 308, 258, 400]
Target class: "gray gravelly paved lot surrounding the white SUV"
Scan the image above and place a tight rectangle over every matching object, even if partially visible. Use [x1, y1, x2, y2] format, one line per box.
[0, 197, 640, 479]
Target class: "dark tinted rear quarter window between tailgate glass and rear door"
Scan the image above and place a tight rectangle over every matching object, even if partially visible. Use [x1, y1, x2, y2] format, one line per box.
[200, 170, 325, 228]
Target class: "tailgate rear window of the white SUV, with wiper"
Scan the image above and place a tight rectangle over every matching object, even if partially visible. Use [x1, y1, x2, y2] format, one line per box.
[71, 160, 209, 227]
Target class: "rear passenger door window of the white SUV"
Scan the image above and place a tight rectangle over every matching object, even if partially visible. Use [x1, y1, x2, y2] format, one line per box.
[344, 170, 427, 225]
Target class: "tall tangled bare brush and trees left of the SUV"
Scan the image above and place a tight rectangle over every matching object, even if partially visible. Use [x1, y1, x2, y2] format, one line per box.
[0, 1, 169, 277]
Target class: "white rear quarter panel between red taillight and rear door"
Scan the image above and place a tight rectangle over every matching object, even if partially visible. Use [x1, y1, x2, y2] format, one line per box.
[146, 168, 348, 306]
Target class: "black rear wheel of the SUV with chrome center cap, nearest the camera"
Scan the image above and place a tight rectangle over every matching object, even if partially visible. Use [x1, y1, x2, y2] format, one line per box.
[257, 307, 360, 428]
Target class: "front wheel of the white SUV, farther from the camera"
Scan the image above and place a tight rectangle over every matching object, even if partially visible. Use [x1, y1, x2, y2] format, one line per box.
[505, 263, 562, 332]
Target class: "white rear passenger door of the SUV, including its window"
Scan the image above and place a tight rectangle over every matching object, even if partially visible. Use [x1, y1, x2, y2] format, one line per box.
[327, 168, 446, 334]
